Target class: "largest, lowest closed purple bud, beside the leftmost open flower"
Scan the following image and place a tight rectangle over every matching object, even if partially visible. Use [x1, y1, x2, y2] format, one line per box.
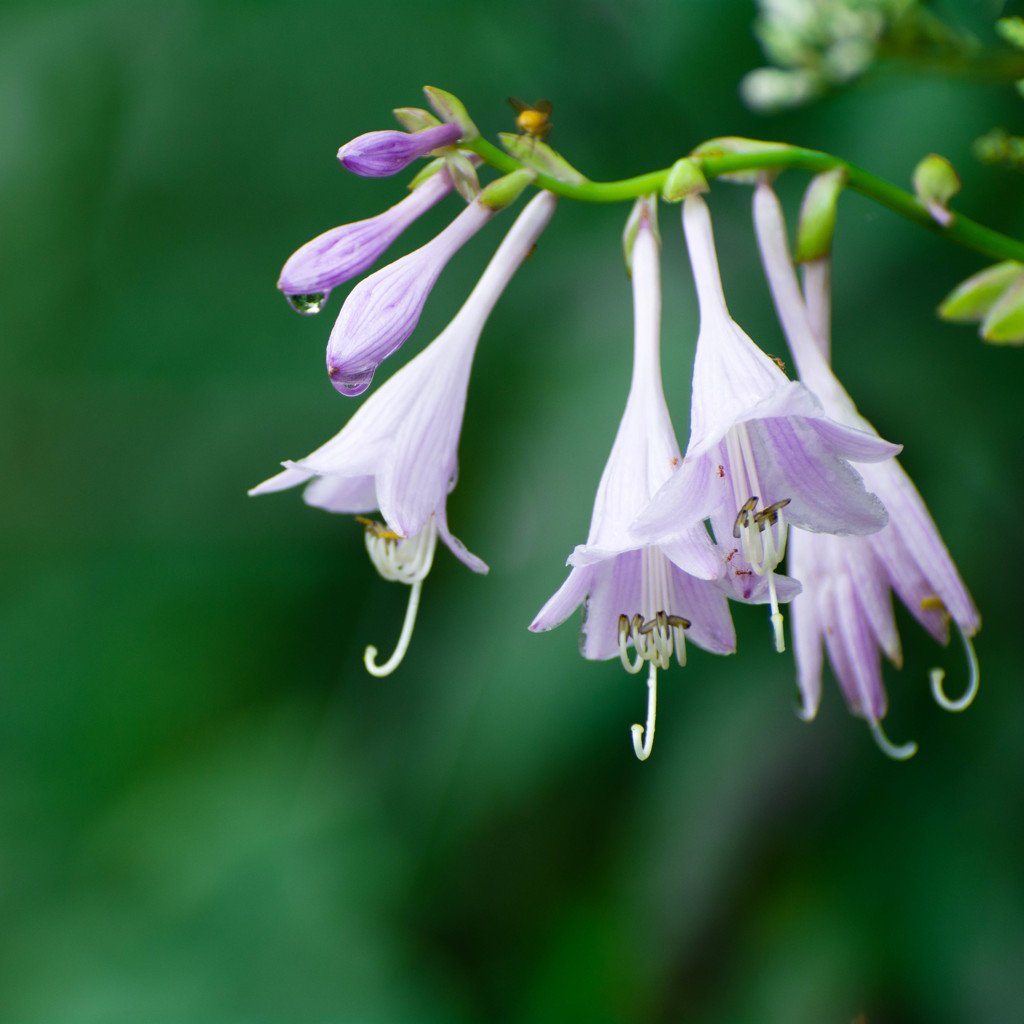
[327, 192, 497, 395]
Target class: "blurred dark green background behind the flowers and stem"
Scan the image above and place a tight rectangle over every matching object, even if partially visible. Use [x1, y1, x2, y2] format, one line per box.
[0, 0, 1024, 1024]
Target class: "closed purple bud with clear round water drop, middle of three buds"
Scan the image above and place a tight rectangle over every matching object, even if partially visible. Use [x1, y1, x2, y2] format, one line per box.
[278, 168, 452, 313]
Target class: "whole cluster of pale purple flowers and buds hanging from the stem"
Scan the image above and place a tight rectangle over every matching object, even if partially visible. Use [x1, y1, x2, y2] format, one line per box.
[250, 90, 980, 760]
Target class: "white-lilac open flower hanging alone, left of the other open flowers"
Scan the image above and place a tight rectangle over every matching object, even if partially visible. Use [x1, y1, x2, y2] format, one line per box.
[250, 193, 555, 675]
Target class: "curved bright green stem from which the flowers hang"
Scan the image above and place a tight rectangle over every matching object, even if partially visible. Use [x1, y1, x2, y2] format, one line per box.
[463, 138, 1024, 262]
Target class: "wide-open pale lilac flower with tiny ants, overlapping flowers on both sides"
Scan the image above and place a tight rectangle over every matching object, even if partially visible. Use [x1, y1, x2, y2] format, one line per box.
[635, 196, 899, 651]
